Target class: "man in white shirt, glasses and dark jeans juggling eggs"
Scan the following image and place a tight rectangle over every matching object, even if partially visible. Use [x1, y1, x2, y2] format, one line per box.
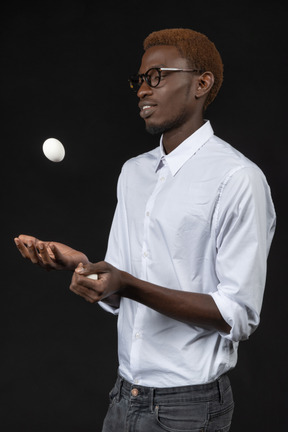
[15, 29, 275, 432]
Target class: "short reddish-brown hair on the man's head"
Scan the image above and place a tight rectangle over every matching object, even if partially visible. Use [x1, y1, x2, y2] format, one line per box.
[143, 28, 223, 109]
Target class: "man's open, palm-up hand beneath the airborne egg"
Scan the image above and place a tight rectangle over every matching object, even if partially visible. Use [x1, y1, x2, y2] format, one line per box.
[14, 235, 89, 271]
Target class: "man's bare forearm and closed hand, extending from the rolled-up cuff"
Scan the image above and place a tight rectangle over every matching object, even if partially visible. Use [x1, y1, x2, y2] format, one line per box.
[70, 262, 230, 333]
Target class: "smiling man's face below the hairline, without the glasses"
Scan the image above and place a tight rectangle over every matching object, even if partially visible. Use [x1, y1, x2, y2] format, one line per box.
[137, 45, 197, 134]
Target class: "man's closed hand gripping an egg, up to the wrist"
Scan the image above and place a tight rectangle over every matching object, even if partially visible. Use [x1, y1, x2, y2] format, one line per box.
[70, 261, 122, 306]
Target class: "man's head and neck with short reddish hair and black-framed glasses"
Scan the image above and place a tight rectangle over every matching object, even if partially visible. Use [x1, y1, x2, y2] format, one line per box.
[130, 29, 223, 145]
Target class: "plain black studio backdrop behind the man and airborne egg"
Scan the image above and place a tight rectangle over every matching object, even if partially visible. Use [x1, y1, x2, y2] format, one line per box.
[0, 0, 288, 432]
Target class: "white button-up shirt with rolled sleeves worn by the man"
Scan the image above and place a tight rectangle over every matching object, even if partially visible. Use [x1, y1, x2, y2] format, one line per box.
[101, 121, 275, 387]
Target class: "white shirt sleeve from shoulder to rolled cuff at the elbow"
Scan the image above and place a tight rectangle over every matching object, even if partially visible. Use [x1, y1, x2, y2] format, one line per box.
[210, 165, 275, 342]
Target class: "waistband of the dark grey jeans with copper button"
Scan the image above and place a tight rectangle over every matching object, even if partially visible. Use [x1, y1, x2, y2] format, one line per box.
[115, 374, 230, 404]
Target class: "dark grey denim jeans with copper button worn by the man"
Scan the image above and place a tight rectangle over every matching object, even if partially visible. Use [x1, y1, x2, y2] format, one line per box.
[102, 375, 234, 432]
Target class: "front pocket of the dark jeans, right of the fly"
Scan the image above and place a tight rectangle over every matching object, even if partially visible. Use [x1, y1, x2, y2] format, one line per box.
[155, 403, 207, 432]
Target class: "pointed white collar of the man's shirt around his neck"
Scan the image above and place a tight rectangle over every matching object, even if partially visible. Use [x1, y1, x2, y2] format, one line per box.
[156, 120, 214, 176]
